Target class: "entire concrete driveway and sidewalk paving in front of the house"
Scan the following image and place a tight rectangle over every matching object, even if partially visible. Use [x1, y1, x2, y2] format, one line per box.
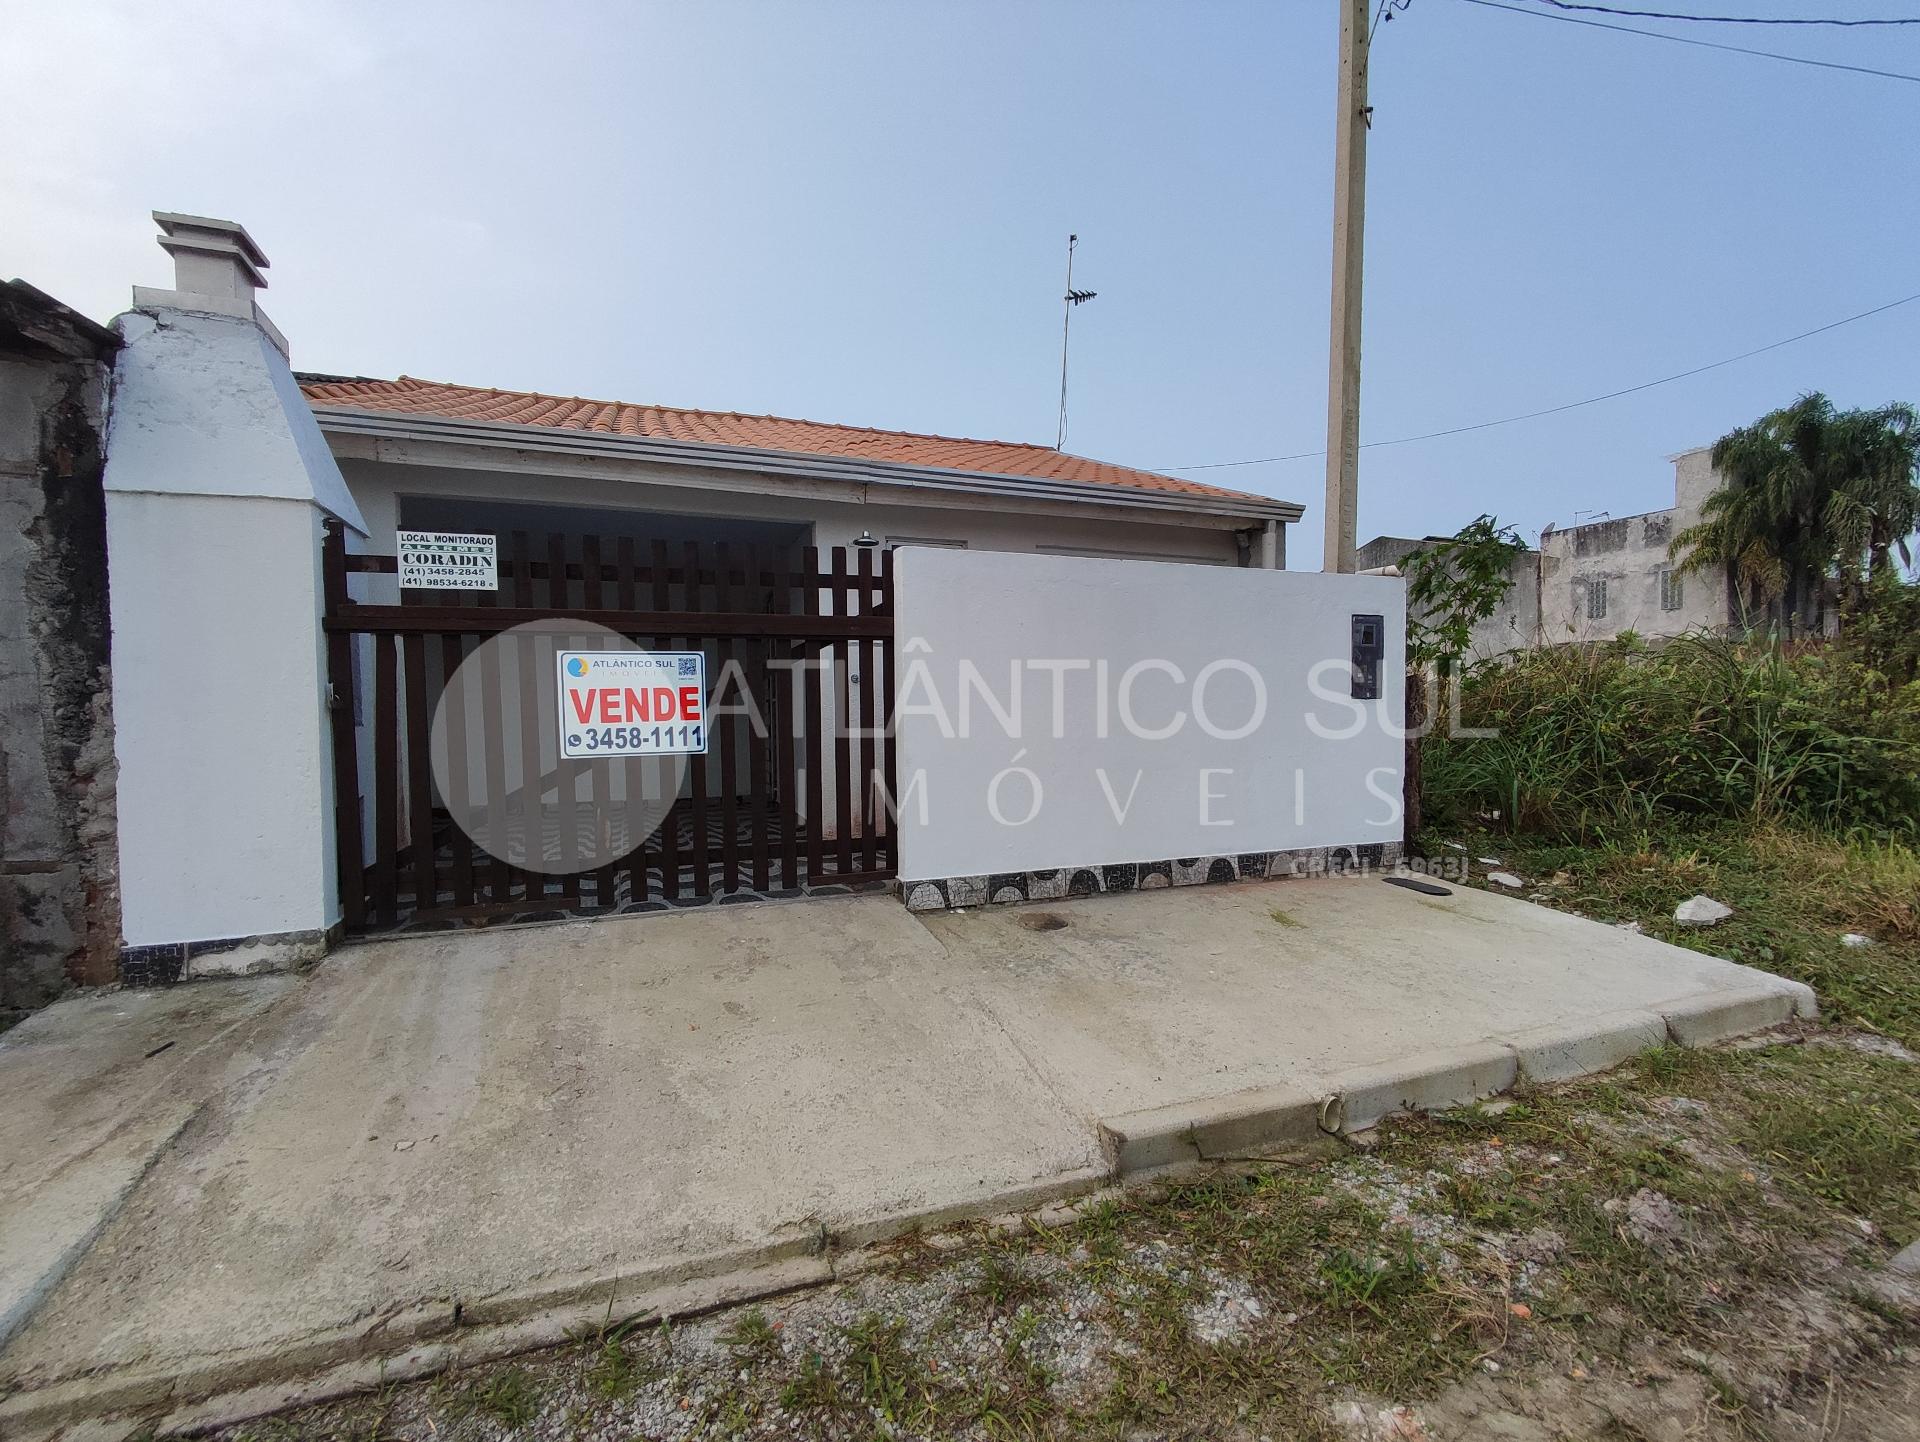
[0, 877, 1812, 1436]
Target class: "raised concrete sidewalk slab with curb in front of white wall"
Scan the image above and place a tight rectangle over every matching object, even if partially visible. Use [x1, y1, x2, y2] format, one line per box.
[925, 879, 1814, 1171]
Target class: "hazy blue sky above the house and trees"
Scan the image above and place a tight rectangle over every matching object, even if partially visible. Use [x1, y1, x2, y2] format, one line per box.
[0, 0, 1920, 568]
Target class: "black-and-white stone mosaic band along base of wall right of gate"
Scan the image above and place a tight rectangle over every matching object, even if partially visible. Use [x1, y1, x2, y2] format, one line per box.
[900, 841, 1402, 912]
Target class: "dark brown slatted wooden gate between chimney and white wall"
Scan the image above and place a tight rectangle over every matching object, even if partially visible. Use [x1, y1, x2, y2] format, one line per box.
[323, 522, 897, 929]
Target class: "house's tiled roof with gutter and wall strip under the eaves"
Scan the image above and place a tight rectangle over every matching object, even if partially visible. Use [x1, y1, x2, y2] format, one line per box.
[300, 374, 1302, 568]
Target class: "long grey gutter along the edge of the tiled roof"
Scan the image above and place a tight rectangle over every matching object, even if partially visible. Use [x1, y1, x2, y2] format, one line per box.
[313, 405, 1304, 522]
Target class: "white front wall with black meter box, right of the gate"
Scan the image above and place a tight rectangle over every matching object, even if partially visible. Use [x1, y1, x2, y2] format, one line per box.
[895, 547, 1405, 881]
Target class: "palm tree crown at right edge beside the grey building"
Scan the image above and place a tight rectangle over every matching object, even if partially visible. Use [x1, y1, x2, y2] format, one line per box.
[1668, 392, 1920, 630]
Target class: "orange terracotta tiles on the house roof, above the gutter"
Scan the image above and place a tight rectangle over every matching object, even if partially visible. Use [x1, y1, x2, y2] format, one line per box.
[301, 376, 1271, 505]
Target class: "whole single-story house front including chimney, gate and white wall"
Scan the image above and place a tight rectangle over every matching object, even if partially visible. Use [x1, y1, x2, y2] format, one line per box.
[31, 211, 1404, 983]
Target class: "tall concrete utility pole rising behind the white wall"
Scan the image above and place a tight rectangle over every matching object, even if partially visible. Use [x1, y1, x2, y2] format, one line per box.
[1321, 0, 1373, 570]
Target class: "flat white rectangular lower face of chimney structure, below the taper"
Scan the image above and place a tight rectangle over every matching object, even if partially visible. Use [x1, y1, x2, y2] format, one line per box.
[108, 492, 340, 947]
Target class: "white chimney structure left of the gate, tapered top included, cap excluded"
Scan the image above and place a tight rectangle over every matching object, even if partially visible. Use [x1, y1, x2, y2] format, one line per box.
[104, 305, 365, 972]
